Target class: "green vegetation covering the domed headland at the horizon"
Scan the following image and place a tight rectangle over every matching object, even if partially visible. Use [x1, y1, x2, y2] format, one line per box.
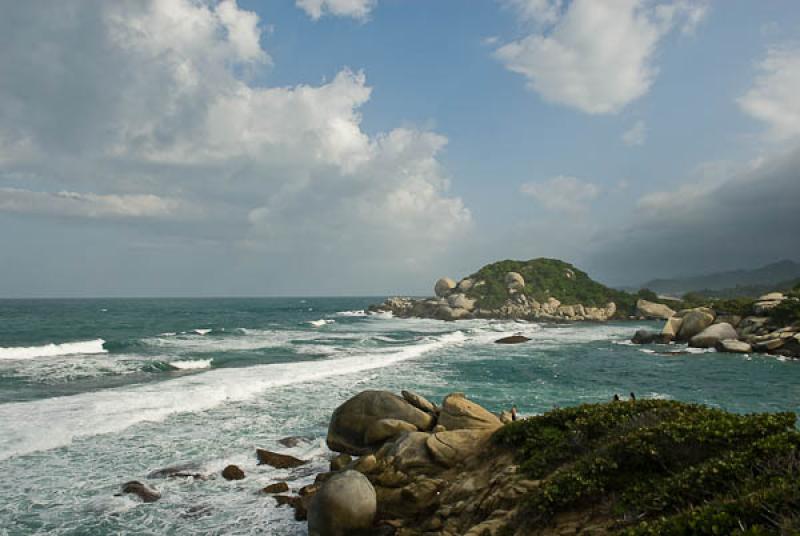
[467, 259, 637, 314]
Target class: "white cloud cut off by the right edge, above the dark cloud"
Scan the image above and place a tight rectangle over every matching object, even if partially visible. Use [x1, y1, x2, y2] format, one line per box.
[738, 47, 800, 140]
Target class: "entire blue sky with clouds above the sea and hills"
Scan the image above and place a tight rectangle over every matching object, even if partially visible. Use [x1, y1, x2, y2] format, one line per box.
[0, 0, 800, 297]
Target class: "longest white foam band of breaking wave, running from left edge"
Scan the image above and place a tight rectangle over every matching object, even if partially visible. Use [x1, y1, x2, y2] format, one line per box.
[0, 331, 465, 460]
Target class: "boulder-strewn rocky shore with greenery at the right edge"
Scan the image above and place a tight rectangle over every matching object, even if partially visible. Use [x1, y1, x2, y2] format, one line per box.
[631, 289, 800, 359]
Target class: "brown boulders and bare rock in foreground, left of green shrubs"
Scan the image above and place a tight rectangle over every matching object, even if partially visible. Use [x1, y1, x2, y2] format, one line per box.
[290, 391, 536, 536]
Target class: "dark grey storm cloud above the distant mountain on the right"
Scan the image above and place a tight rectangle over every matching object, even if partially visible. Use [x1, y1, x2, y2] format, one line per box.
[588, 148, 800, 285]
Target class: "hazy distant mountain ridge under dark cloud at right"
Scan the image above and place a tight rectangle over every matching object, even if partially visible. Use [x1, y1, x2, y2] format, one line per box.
[642, 260, 800, 296]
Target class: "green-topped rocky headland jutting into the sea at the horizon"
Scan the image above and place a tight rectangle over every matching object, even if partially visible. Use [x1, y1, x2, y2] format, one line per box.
[370, 259, 636, 322]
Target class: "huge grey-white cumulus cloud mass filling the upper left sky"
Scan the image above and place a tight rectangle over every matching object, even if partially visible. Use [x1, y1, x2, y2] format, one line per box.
[0, 0, 471, 292]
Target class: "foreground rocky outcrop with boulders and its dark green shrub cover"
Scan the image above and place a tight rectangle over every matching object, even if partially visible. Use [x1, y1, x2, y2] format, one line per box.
[296, 391, 800, 536]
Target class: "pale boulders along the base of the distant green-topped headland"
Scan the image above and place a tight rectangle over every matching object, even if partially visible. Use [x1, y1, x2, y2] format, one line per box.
[369, 270, 617, 322]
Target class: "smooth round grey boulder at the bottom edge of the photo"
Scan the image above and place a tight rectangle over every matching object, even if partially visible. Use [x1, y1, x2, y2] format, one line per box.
[308, 471, 378, 536]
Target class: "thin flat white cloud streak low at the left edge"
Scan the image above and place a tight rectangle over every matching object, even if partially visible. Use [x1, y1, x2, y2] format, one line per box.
[0, 188, 202, 220]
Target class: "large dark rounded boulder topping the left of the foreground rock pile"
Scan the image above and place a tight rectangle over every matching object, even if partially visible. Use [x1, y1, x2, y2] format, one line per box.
[327, 391, 434, 456]
